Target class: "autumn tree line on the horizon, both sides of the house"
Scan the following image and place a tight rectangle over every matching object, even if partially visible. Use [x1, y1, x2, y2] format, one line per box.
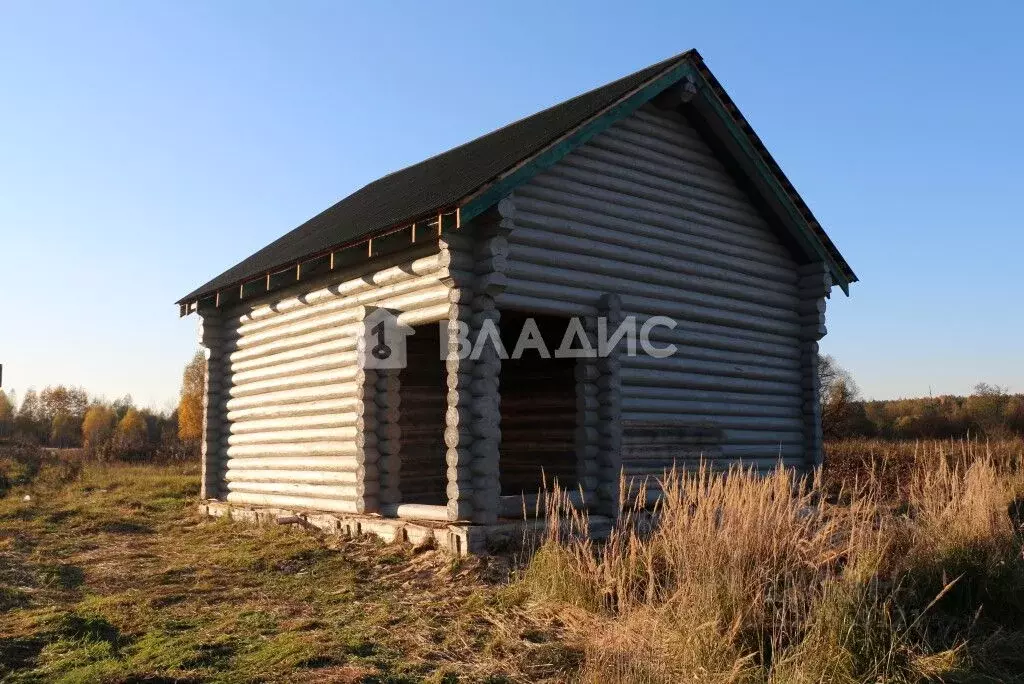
[0, 352, 1024, 460]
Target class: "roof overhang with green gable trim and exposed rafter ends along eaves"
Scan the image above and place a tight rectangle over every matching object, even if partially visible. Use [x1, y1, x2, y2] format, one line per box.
[177, 50, 857, 315]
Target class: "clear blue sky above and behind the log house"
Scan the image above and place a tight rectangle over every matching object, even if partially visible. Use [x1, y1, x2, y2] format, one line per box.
[0, 0, 1024, 408]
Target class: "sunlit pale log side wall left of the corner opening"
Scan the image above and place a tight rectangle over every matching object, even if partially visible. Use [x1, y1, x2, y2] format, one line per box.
[204, 246, 456, 513]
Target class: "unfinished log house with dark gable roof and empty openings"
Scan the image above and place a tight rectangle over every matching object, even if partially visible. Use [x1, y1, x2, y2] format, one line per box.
[178, 51, 856, 552]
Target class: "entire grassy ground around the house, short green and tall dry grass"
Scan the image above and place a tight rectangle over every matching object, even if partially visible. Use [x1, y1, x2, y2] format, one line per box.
[0, 441, 1024, 683]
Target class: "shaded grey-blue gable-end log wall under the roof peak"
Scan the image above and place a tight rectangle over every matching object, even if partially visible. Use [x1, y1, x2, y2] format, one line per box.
[497, 102, 811, 485]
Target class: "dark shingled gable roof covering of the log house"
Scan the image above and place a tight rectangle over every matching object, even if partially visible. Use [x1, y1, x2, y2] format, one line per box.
[178, 50, 856, 304]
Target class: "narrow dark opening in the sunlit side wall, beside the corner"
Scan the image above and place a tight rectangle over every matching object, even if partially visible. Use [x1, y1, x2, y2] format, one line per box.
[398, 324, 447, 506]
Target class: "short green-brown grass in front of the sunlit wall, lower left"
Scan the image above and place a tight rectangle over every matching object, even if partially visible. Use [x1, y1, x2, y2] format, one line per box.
[0, 448, 580, 682]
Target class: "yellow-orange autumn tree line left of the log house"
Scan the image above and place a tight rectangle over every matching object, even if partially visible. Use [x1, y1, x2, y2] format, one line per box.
[0, 352, 205, 460]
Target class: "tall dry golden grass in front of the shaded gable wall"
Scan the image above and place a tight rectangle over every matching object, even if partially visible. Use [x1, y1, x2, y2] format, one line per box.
[523, 442, 1024, 682]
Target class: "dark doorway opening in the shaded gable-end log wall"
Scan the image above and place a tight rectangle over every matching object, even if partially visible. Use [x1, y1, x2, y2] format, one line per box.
[500, 311, 578, 497]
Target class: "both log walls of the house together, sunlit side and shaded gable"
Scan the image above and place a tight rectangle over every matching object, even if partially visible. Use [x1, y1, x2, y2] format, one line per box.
[201, 102, 830, 523]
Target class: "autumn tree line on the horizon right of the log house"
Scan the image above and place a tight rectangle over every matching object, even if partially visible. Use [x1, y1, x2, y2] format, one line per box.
[818, 355, 1024, 439]
